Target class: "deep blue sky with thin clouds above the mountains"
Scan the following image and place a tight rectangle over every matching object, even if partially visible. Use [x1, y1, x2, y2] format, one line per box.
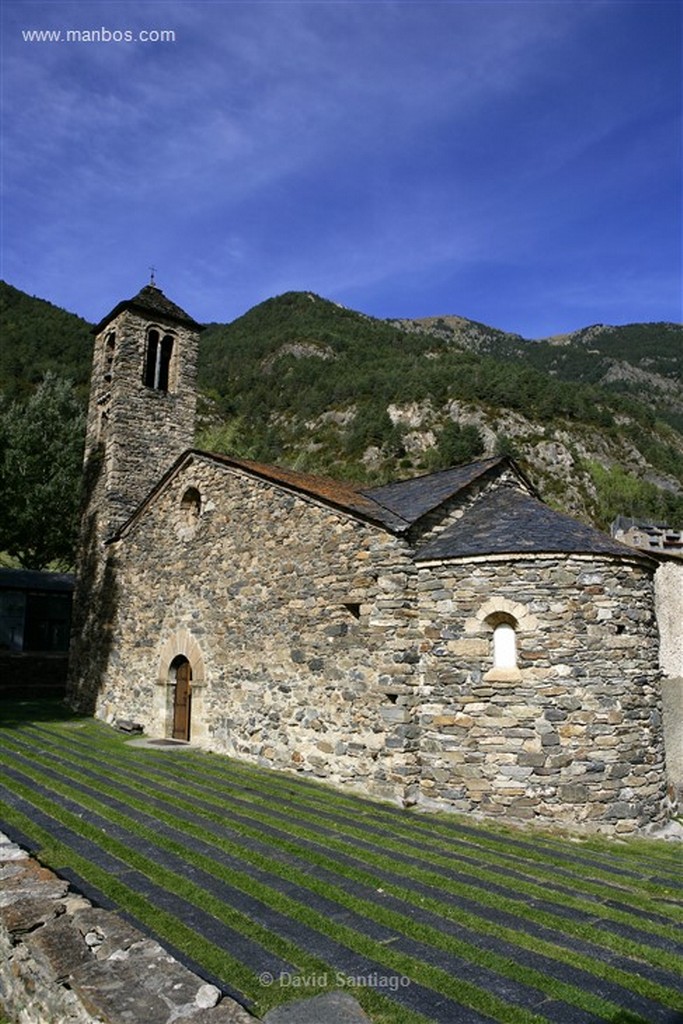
[0, 0, 683, 338]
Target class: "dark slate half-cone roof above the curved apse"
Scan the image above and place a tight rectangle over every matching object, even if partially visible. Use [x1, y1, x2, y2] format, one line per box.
[415, 486, 633, 561]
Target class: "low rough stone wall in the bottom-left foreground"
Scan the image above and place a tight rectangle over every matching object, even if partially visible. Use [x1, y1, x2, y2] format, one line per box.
[0, 833, 256, 1024]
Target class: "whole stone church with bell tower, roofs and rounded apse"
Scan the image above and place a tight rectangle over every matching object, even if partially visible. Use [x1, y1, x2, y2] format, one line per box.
[69, 285, 683, 833]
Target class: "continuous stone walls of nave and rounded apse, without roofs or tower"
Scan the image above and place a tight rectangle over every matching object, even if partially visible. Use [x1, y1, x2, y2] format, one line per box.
[76, 454, 665, 833]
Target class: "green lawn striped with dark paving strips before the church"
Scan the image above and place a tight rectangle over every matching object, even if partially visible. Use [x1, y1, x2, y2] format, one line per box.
[0, 702, 683, 1024]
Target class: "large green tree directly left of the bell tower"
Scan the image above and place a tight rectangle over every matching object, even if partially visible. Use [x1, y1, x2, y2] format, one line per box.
[0, 373, 84, 569]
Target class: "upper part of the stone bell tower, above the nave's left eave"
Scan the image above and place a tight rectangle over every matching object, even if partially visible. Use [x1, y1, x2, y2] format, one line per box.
[85, 283, 202, 541]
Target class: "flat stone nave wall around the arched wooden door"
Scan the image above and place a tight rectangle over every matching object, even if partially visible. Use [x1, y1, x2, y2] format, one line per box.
[98, 457, 418, 799]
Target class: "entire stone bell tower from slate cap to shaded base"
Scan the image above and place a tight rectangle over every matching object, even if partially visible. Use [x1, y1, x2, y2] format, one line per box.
[67, 282, 202, 714]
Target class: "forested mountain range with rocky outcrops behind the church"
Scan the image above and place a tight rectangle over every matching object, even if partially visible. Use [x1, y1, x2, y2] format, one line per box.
[0, 286, 683, 527]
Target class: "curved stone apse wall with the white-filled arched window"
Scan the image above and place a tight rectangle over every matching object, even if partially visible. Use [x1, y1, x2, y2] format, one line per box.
[417, 556, 665, 833]
